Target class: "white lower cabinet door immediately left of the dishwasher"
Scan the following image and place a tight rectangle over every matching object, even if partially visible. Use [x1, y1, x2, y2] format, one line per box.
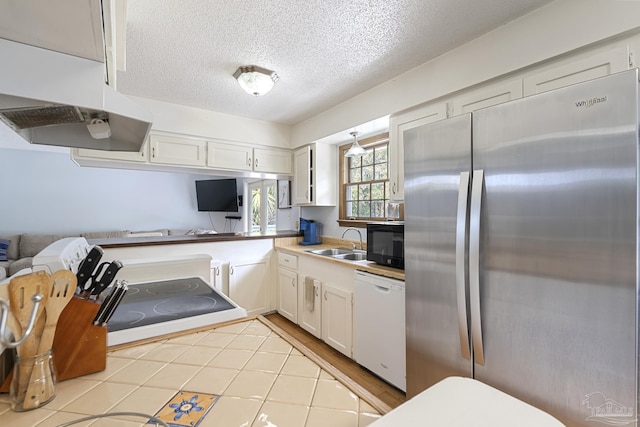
[322, 283, 353, 357]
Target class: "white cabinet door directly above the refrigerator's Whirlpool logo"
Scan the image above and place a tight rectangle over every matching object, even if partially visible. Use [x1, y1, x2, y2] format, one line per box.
[524, 46, 629, 96]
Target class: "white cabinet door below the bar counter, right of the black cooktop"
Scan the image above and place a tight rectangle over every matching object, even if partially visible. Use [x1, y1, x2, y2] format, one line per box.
[229, 258, 270, 316]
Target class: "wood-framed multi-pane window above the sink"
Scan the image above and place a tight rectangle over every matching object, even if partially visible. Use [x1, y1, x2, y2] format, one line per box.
[338, 133, 399, 227]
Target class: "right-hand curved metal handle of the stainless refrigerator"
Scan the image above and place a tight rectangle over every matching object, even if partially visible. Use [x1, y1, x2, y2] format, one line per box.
[469, 170, 484, 366]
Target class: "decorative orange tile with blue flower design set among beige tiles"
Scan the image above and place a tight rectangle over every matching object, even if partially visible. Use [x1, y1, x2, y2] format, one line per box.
[154, 391, 220, 427]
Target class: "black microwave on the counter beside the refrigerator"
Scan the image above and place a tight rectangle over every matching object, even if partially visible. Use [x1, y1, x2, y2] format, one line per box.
[367, 221, 404, 269]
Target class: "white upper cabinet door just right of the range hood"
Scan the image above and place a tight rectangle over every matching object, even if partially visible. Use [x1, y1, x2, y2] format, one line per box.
[149, 135, 207, 166]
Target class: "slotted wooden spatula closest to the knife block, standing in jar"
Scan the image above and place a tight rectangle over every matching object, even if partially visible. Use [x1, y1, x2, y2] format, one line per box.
[24, 270, 78, 409]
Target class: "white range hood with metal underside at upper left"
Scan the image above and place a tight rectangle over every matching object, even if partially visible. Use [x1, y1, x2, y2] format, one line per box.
[0, 39, 152, 152]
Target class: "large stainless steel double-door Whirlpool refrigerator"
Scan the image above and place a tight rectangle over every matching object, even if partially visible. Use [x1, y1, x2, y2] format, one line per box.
[404, 70, 639, 426]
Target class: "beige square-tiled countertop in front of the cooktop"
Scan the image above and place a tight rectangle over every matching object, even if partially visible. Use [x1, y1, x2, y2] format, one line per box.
[0, 320, 380, 427]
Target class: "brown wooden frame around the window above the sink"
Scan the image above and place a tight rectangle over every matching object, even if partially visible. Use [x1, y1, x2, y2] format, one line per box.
[338, 132, 404, 228]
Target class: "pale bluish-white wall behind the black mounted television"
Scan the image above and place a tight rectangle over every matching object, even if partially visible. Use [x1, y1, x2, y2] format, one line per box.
[0, 148, 242, 234]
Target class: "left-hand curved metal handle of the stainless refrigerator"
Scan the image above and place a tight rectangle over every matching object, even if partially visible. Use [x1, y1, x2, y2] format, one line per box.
[456, 172, 471, 360]
